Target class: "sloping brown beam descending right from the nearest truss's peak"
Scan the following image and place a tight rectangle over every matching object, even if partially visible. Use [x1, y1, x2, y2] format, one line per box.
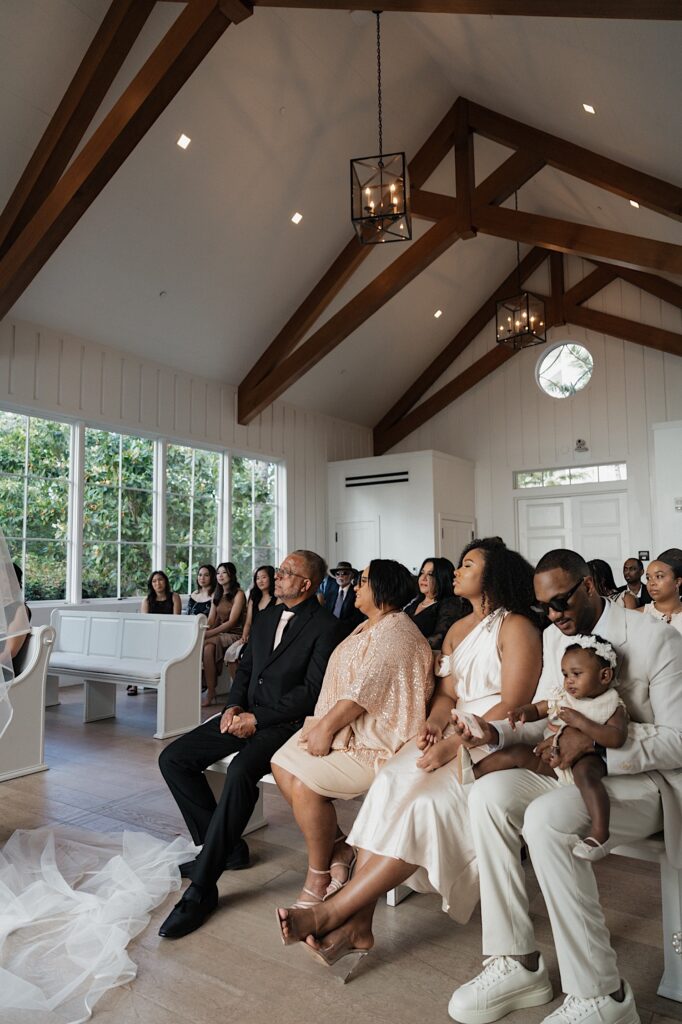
[469, 100, 682, 220]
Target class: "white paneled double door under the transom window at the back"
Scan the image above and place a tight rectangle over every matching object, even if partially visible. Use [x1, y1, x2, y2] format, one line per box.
[516, 490, 632, 583]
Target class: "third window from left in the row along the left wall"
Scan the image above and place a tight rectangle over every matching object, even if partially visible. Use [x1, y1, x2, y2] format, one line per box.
[166, 444, 222, 594]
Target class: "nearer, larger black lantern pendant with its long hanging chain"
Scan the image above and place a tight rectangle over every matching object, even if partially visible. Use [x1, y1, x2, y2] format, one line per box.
[350, 10, 412, 245]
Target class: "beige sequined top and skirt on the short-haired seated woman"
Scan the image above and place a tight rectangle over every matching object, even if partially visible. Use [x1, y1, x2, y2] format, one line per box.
[272, 611, 433, 800]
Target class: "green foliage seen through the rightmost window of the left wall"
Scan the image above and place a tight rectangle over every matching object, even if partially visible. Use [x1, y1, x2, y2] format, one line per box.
[231, 456, 278, 589]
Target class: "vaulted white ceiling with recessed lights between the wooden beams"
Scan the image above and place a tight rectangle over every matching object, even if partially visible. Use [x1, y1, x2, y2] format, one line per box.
[0, 0, 682, 425]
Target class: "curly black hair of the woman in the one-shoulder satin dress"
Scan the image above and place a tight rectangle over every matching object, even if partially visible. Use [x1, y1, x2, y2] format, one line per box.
[458, 537, 542, 629]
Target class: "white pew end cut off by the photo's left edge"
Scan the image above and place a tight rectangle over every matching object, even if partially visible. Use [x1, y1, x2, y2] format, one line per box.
[0, 626, 54, 782]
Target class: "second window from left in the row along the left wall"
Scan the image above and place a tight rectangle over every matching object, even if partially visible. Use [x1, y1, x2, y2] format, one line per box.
[82, 428, 153, 598]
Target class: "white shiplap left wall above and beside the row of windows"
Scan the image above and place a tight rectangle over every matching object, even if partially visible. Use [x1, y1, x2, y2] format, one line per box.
[0, 317, 372, 554]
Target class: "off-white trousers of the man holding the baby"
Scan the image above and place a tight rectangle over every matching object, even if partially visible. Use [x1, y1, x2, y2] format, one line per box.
[469, 768, 663, 998]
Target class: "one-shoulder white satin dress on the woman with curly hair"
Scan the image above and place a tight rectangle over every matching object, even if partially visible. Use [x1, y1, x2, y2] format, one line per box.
[348, 608, 507, 924]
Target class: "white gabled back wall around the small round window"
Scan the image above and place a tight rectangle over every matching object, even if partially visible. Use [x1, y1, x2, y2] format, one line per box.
[392, 258, 682, 553]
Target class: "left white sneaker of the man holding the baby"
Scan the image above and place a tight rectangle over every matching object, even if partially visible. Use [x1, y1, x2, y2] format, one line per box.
[447, 956, 552, 1024]
